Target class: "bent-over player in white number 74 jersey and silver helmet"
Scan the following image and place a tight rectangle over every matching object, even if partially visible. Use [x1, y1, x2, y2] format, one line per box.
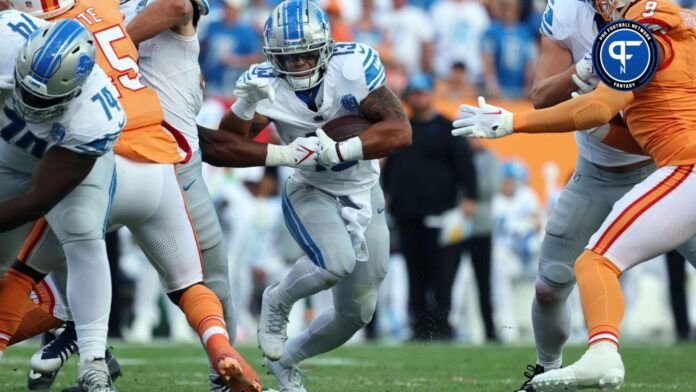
[0, 10, 126, 391]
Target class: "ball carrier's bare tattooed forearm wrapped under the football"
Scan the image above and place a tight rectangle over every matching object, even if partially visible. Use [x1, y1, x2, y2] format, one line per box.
[359, 119, 412, 160]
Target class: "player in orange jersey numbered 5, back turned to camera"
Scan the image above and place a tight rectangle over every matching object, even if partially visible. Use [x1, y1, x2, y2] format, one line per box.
[1, 0, 260, 390]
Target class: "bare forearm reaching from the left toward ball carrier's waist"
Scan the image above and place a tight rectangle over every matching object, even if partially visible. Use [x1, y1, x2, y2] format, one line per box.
[198, 125, 268, 167]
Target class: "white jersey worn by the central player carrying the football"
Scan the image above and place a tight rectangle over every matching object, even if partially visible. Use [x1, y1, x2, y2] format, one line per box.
[239, 42, 386, 195]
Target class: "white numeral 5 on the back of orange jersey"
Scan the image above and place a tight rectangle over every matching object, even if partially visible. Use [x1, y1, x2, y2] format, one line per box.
[94, 26, 145, 98]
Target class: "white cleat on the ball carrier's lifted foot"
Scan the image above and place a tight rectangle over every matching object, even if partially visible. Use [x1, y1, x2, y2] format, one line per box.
[258, 283, 289, 360]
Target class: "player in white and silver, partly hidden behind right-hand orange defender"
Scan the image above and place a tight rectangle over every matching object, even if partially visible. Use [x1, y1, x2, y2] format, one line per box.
[506, 0, 696, 391]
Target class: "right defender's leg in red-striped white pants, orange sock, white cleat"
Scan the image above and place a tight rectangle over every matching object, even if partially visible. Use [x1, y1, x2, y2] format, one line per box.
[532, 166, 696, 387]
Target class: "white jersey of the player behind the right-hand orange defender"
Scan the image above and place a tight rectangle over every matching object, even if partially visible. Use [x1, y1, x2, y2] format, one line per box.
[540, 0, 649, 166]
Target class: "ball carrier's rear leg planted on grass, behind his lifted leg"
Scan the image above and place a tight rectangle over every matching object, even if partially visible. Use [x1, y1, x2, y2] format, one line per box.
[266, 186, 389, 390]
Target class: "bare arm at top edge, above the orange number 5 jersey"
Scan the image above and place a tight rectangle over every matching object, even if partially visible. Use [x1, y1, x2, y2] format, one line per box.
[126, 0, 193, 45]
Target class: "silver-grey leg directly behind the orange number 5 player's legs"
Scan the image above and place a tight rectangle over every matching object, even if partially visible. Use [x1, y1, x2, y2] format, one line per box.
[176, 153, 237, 343]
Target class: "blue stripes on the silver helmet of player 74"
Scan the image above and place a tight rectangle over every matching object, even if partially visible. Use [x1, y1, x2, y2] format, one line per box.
[31, 19, 84, 81]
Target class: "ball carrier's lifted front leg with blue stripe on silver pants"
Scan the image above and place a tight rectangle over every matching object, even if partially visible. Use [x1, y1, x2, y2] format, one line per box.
[258, 179, 356, 360]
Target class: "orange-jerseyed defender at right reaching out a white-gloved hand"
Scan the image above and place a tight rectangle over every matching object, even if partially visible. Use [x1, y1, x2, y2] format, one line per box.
[453, 0, 696, 391]
